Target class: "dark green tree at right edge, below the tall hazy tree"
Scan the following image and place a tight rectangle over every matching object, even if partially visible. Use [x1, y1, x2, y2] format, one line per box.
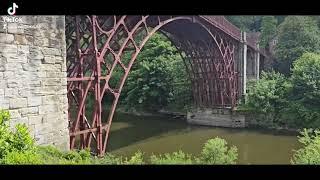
[289, 53, 320, 128]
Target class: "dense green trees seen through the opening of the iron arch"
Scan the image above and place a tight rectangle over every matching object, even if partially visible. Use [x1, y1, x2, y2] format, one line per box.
[121, 33, 191, 111]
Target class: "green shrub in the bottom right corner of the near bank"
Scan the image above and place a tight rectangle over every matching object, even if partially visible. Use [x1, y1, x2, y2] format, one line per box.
[291, 129, 320, 165]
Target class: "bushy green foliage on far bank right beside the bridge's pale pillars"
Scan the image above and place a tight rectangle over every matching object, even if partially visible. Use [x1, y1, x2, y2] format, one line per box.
[241, 71, 292, 127]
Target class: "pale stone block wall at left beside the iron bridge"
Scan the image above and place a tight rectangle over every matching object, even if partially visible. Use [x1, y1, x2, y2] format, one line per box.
[0, 16, 69, 149]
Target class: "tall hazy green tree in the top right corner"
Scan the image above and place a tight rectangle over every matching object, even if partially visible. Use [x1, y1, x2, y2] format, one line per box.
[275, 16, 320, 74]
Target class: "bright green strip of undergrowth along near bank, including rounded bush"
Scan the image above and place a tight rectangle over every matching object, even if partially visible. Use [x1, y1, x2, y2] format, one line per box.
[0, 110, 238, 165]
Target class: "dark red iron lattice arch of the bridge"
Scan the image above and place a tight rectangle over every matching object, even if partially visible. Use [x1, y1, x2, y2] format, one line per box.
[66, 16, 245, 155]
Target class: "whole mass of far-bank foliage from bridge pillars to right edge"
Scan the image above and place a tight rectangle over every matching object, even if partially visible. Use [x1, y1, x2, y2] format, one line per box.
[243, 53, 320, 128]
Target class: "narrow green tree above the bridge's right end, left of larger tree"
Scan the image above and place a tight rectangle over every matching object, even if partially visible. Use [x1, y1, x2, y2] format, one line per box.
[260, 16, 277, 48]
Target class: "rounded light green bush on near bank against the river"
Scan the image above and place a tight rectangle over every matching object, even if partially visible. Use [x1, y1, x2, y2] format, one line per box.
[199, 137, 238, 164]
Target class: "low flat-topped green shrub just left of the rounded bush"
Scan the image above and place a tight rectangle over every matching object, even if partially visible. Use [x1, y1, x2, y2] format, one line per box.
[150, 151, 192, 164]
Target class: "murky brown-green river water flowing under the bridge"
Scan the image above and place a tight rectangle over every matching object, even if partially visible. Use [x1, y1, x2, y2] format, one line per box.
[108, 114, 299, 164]
